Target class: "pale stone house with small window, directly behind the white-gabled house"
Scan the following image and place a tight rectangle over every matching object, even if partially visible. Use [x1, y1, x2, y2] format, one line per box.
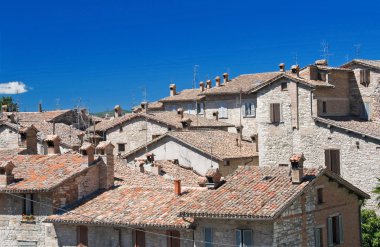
[88, 109, 231, 155]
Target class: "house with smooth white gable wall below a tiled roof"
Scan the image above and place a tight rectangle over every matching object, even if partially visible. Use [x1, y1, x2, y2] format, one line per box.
[121, 130, 258, 176]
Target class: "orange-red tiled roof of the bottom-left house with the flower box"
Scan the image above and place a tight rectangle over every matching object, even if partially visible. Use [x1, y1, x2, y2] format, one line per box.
[0, 153, 88, 192]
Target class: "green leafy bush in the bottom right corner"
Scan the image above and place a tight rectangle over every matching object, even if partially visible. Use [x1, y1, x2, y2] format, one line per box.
[362, 209, 380, 247]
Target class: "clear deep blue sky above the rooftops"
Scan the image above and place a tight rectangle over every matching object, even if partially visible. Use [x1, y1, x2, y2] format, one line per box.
[0, 0, 380, 112]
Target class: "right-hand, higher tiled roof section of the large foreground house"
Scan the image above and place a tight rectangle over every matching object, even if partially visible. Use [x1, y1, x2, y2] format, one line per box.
[180, 166, 369, 219]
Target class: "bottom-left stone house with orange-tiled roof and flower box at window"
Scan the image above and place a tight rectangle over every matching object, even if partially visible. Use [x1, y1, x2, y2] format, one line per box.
[0, 141, 114, 247]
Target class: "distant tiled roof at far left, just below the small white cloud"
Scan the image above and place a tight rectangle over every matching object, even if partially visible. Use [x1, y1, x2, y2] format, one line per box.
[1, 110, 71, 123]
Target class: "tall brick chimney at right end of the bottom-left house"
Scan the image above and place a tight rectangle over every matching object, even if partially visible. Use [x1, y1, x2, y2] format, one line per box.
[96, 141, 115, 189]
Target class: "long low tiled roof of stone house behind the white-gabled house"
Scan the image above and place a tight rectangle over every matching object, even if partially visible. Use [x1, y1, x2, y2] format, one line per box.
[88, 111, 233, 131]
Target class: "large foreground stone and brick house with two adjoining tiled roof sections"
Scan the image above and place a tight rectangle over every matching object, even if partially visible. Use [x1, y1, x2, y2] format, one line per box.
[45, 155, 369, 247]
